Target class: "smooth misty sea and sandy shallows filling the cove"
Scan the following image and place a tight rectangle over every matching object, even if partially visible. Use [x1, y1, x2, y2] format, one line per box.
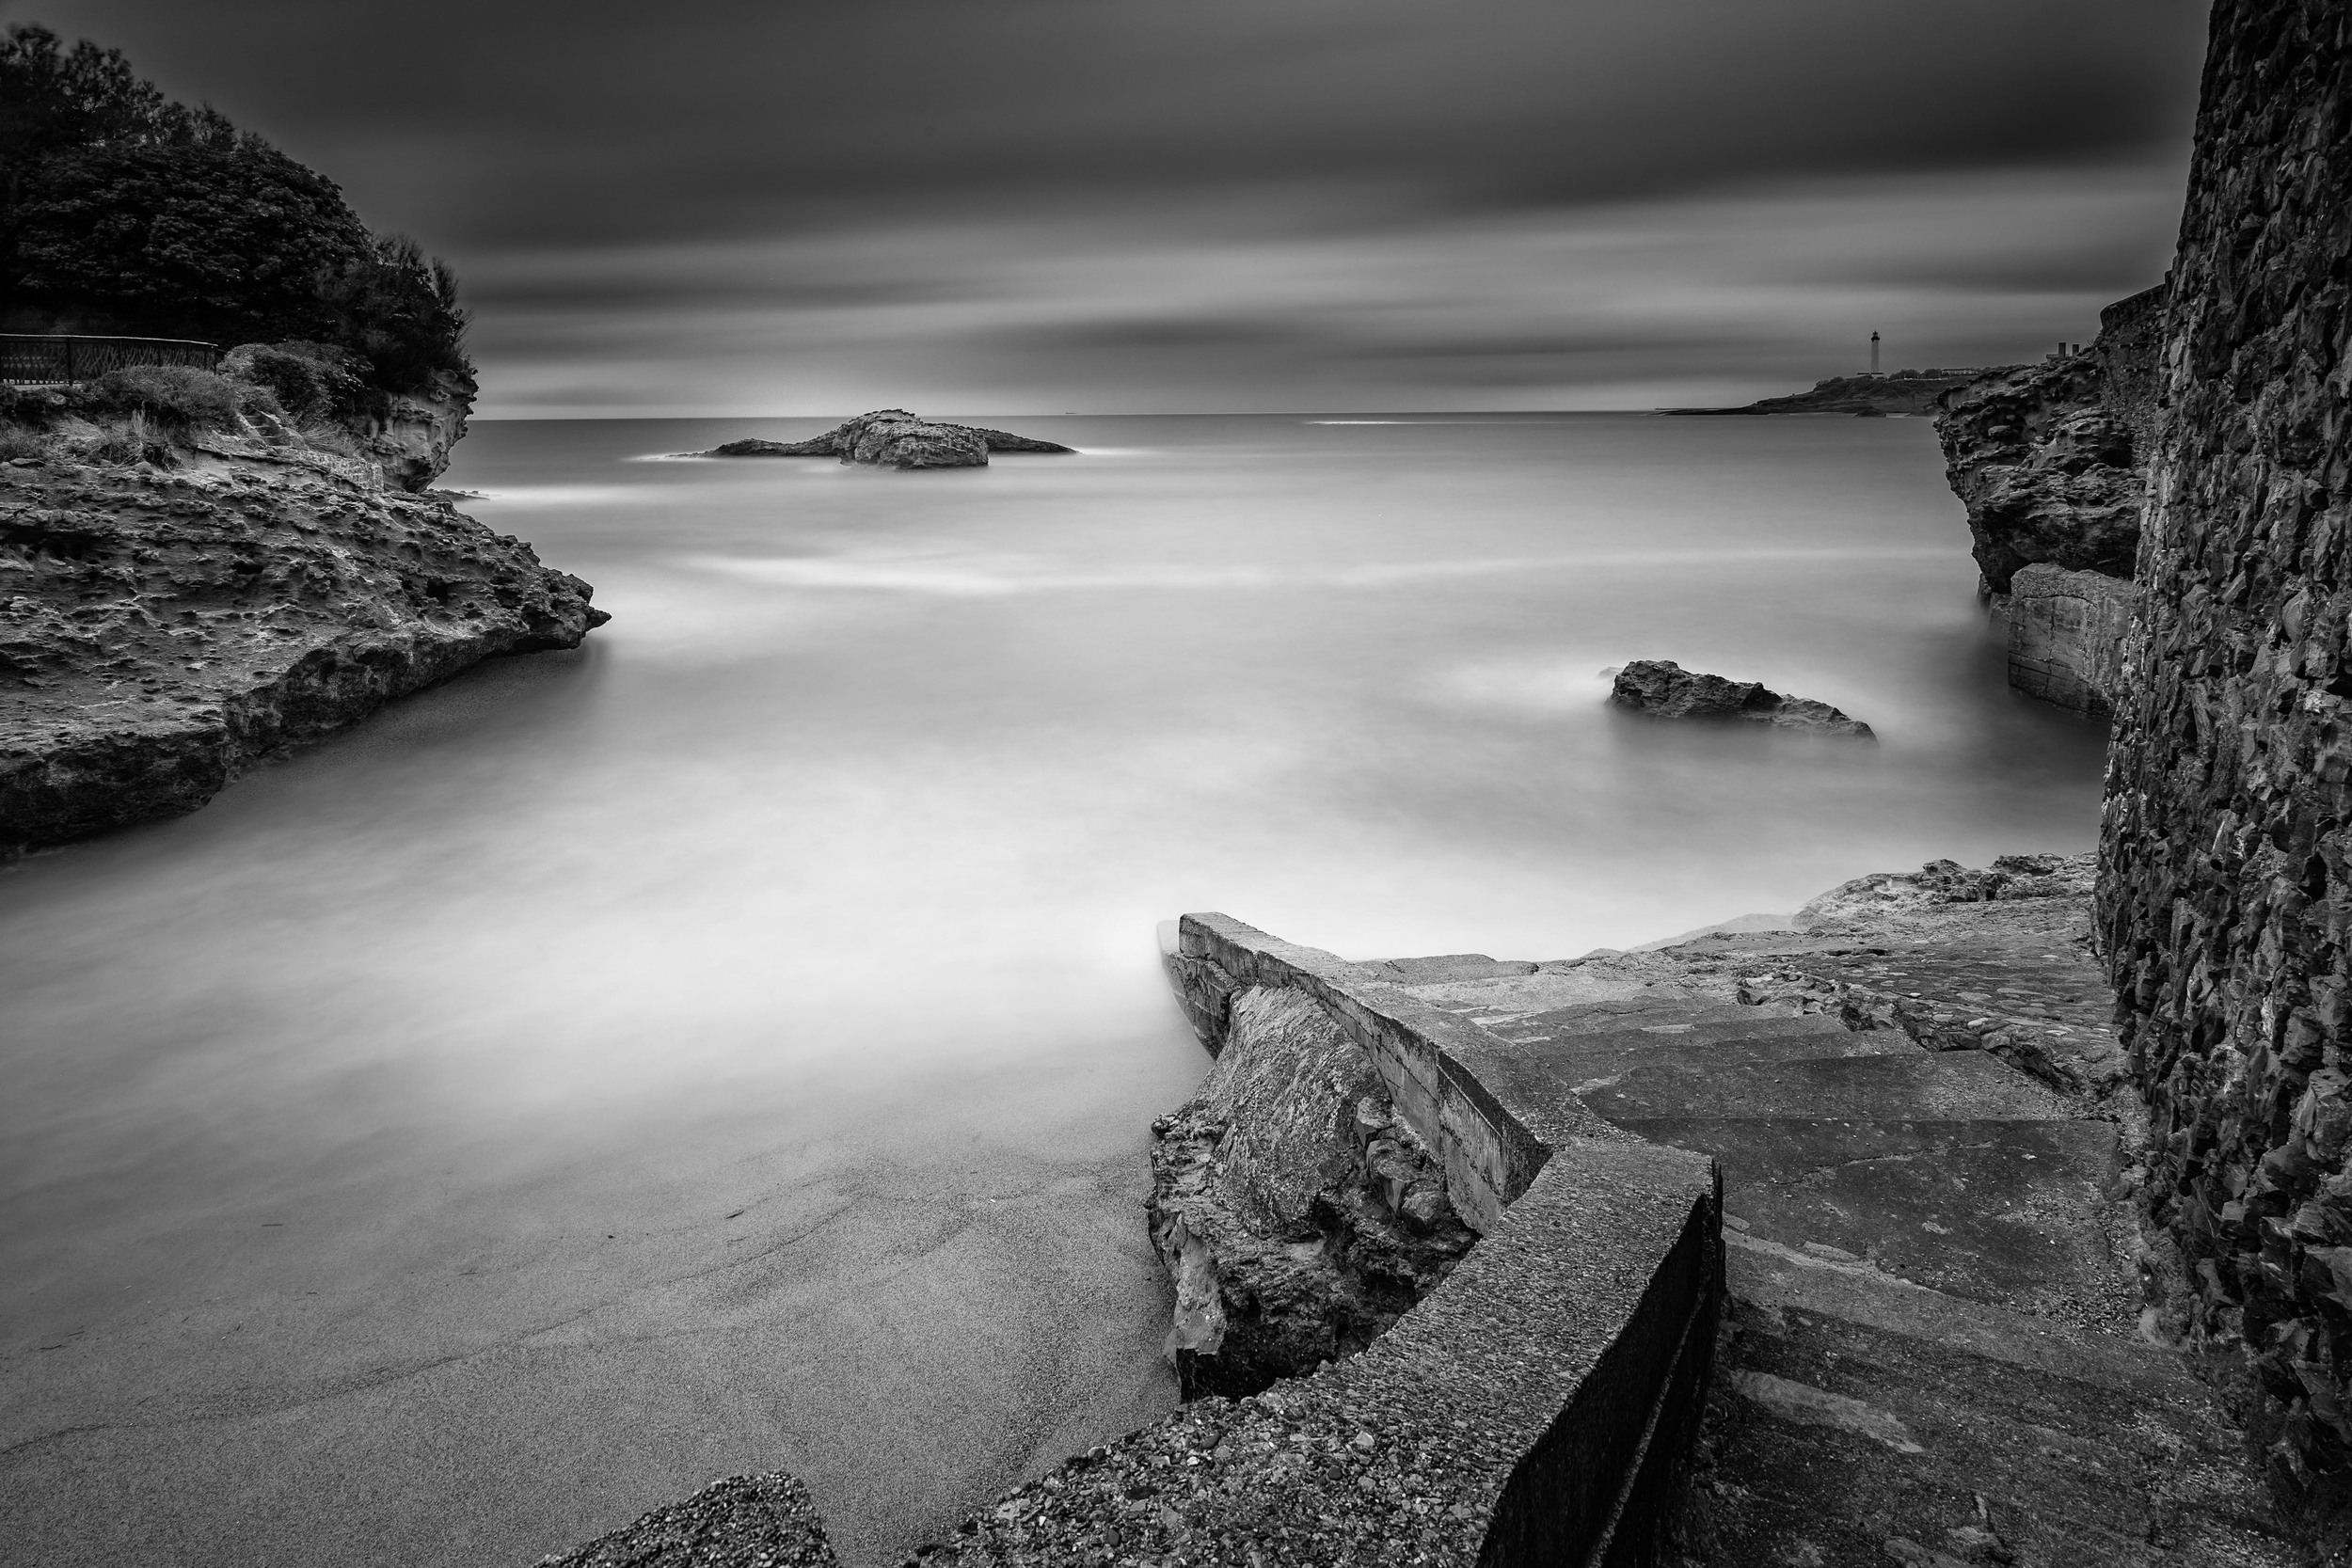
[0, 416, 2103, 1566]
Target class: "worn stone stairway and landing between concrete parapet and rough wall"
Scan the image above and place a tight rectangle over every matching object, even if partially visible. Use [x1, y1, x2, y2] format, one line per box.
[1392, 952, 2300, 1568]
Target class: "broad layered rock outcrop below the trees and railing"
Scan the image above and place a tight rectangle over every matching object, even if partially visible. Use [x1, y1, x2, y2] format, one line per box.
[0, 437, 607, 856]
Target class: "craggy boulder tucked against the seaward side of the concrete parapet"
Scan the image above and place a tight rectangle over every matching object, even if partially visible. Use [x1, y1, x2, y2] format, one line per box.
[1148, 988, 1477, 1399]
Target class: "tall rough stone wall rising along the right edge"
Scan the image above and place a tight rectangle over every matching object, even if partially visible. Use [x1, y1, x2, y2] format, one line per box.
[2101, 0, 2352, 1547]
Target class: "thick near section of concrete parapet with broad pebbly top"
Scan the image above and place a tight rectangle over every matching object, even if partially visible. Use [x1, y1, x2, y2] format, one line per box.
[922, 1140, 1722, 1568]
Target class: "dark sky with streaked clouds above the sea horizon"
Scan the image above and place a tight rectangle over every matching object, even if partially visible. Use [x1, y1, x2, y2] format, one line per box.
[13, 0, 2206, 419]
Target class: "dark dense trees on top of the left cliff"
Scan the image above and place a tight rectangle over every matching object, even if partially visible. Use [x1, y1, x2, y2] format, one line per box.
[0, 24, 473, 392]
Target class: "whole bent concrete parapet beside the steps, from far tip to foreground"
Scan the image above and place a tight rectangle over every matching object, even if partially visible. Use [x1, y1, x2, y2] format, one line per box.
[889, 914, 1724, 1568]
